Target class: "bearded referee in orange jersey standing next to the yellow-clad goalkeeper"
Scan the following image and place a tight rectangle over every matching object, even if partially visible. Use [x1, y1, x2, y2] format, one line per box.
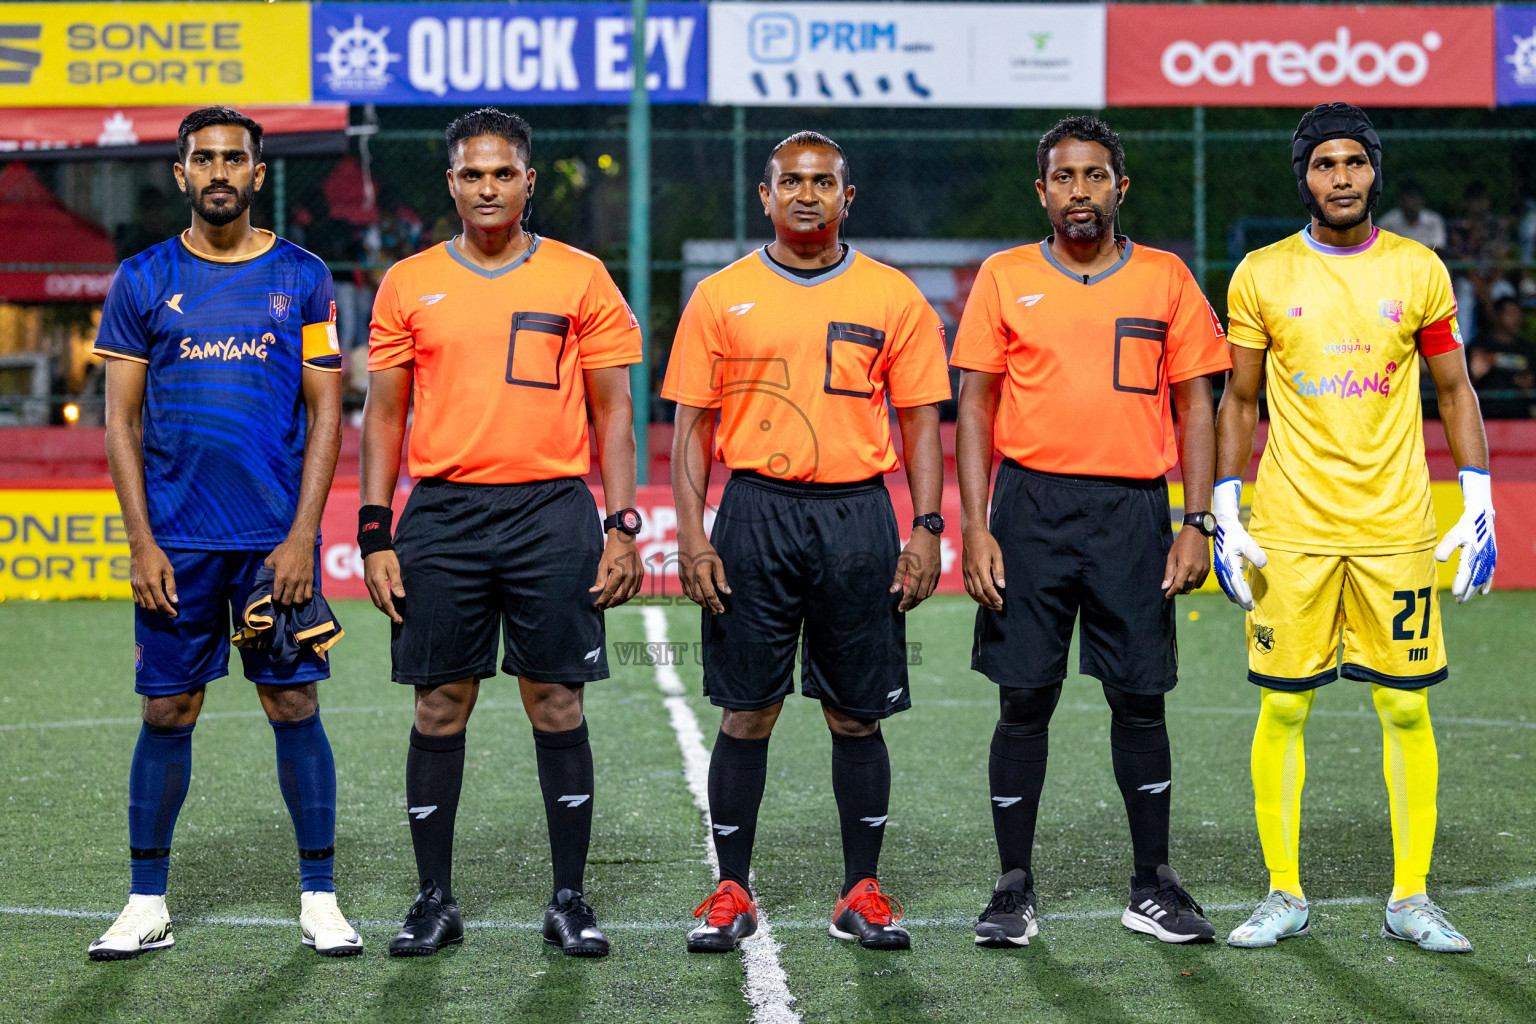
[951, 117, 1232, 947]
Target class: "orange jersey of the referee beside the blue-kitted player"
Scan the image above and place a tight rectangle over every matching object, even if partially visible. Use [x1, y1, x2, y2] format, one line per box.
[369, 235, 641, 484]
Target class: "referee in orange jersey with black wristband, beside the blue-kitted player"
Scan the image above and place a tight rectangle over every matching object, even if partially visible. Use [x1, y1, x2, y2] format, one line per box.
[358, 109, 641, 956]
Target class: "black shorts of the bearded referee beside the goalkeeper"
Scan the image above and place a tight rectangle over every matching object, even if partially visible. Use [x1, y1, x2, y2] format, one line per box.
[971, 459, 1178, 694]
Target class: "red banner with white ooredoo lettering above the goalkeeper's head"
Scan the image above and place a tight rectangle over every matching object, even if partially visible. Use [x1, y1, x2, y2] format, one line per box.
[1107, 3, 1495, 106]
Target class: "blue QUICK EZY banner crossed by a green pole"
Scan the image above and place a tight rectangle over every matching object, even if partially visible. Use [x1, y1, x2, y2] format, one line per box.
[312, 3, 707, 106]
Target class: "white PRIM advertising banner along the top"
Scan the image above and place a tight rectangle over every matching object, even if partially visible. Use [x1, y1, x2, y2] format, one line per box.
[710, 3, 1104, 107]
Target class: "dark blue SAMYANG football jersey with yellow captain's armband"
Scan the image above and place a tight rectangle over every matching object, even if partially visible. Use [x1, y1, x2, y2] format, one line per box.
[95, 232, 341, 551]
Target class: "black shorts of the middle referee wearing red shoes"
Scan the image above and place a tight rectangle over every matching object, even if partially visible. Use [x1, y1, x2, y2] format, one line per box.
[703, 471, 912, 718]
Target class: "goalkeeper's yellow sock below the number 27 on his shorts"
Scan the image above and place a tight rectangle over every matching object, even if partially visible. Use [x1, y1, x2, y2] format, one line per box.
[1370, 683, 1439, 900]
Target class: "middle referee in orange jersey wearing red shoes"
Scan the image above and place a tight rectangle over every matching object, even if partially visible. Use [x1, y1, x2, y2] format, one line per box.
[662, 132, 949, 952]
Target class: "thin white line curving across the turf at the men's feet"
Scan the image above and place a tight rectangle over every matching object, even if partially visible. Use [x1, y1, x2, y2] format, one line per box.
[12, 878, 1536, 933]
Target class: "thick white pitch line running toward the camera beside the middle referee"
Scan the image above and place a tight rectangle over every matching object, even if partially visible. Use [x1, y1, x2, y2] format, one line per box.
[642, 608, 800, 1024]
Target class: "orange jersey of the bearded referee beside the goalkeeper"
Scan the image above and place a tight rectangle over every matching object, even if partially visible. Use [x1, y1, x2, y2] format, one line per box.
[949, 239, 1232, 481]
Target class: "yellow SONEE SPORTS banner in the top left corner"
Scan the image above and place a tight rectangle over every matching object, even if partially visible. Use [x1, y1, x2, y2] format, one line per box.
[0, 3, 310, 107]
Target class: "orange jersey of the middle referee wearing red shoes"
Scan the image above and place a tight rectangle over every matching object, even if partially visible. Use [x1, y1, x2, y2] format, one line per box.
[662, 247, 949, 484]
